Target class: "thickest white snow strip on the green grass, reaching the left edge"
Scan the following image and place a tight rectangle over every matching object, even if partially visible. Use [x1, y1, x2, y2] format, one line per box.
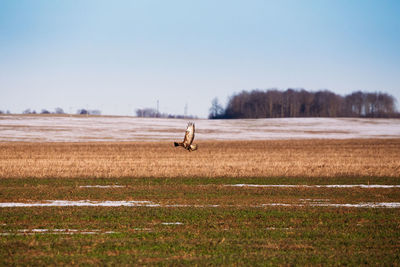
[0, 200, 160, 208]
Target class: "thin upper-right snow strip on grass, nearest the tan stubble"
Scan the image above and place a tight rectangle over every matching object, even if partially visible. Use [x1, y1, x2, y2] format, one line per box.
[224, 184, 400, 188]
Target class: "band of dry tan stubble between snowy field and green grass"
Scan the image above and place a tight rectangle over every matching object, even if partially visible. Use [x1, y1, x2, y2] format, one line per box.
[0, 139, 400, 178]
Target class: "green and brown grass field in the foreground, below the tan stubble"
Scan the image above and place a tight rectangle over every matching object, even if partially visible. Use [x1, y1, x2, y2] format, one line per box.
[0, 177, 400, 266]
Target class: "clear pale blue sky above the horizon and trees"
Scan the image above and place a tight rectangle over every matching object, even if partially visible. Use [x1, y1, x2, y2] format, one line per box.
[0, 0, 400, 118]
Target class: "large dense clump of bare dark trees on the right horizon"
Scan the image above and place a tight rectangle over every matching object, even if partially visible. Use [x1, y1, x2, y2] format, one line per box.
[209, 89, 400, 119]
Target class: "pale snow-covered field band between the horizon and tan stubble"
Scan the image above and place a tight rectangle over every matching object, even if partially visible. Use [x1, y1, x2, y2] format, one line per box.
[0, 115, 400, 142]
